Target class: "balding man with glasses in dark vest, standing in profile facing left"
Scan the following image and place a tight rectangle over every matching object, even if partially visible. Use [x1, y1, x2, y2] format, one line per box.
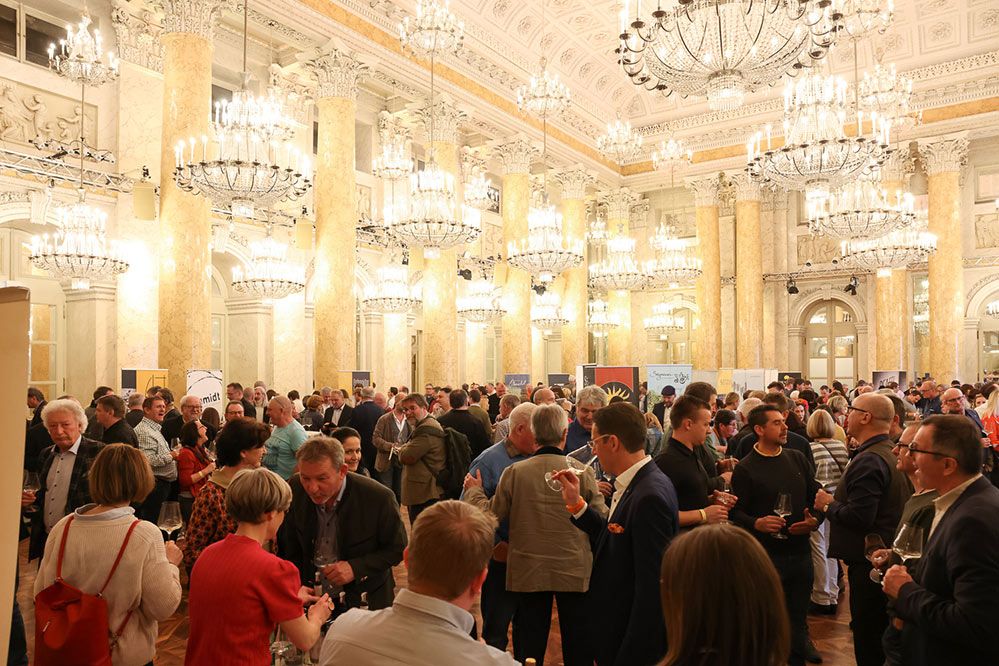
[815, 393, 912, 666]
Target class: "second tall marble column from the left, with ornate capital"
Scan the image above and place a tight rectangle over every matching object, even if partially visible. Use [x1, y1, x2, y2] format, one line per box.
[309, 48, 367, 388]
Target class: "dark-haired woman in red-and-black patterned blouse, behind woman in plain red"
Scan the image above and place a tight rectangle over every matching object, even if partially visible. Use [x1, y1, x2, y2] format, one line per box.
[184, 418, 271, 574]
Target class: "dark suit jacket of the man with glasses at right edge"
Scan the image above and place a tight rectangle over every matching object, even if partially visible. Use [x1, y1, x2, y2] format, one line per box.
[895, 477, 999, 666]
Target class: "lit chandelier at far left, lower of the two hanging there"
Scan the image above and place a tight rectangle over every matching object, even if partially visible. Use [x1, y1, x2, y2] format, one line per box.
[29, 187, 129, 289]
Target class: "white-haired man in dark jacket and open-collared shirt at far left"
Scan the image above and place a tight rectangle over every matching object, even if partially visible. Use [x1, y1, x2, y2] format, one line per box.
[28, 399, 103, 560]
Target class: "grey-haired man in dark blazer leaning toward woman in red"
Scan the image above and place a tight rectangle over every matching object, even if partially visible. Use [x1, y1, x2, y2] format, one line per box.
[278, 437, 406, 614]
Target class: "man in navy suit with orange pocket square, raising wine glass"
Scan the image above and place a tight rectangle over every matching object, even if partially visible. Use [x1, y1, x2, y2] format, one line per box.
[556, 402, 679, 666]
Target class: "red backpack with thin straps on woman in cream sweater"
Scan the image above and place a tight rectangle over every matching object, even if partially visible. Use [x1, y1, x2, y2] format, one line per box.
[35, 515, 139, 666]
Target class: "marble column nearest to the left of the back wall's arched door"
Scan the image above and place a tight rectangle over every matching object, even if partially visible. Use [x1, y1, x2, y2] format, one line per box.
[732, 173, 763, 368]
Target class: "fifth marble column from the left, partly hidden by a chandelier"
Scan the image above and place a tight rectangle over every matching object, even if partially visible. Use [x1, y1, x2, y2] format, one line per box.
[555, 164, 596, 374]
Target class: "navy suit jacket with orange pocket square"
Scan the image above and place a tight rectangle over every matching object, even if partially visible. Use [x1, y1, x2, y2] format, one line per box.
[573, 460, 679, 666]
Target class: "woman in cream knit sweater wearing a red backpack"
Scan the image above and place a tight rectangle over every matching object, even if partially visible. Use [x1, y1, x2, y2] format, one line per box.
[34, 444, 183, 666]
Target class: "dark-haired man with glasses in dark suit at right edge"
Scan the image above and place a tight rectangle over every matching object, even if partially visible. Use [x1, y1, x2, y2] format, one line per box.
[884, 415, 999, 666]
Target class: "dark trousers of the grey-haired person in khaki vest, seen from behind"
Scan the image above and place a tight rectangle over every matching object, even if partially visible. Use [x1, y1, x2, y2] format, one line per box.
[513, 592, 593, 666]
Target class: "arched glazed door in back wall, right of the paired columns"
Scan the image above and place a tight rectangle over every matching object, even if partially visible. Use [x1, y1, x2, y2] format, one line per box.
[802, 299, 858, 385]
